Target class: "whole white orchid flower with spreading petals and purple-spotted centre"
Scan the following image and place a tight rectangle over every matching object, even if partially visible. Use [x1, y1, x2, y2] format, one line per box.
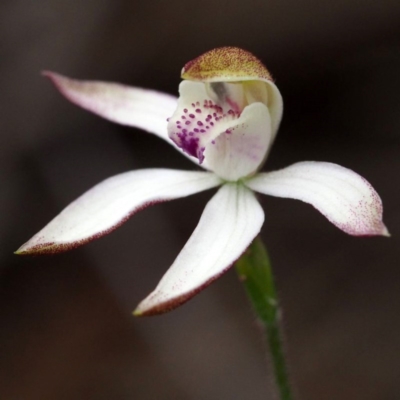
[17, 47, 388, 315]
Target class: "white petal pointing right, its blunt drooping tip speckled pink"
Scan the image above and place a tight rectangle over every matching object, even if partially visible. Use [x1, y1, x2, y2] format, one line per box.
[246, 161, 388, 236]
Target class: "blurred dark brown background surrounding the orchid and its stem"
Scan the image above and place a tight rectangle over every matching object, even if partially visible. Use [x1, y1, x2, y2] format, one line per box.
[0, 0, 400, 400]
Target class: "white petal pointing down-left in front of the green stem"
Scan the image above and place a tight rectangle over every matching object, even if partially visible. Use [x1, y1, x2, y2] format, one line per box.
[135, 184, 264, 315]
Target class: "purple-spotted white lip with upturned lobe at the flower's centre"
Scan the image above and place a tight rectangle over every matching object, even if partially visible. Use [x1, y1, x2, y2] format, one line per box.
[168, 81, 271, 181]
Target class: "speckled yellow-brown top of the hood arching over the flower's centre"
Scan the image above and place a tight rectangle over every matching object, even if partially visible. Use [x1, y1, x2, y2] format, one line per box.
[182, 47, 272, 82]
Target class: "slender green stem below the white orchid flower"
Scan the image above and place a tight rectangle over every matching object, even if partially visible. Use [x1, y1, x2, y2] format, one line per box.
[236, 238, 293, 400]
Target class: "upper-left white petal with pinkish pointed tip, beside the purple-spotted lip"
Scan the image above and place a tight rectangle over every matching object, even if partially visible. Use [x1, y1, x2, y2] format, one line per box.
[43, 71, 177, 143]
